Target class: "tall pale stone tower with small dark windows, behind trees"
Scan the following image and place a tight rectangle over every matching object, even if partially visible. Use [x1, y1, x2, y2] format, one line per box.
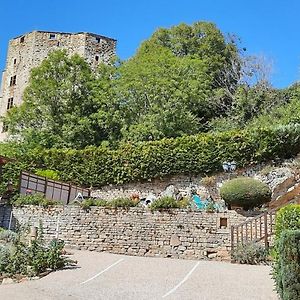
[0, 31, 116, 141]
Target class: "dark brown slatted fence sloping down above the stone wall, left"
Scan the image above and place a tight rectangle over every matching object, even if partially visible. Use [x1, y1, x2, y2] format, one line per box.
[19, 172, 90, 204]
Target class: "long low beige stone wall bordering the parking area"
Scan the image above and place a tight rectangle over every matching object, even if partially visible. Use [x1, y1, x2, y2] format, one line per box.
[0, 206, 245, 259]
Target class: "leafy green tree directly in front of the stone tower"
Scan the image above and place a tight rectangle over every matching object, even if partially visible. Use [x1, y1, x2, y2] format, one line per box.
[5, 51, 120, 148]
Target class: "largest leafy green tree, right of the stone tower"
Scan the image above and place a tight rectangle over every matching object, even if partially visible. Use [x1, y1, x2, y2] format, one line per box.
[117, 22, 237, 140]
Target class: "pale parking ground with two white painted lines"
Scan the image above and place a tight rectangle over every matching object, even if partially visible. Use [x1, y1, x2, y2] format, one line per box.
[0, 251, 277, 300]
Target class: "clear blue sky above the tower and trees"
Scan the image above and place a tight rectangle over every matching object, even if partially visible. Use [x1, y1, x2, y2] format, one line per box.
[0, 0, 300, 87]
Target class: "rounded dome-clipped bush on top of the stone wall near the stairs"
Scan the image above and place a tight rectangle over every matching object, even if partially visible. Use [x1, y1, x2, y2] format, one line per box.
[220, 177, 271, 210]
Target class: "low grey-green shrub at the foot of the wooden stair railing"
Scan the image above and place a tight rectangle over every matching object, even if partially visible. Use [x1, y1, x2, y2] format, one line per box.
[232, 242, 268, 265]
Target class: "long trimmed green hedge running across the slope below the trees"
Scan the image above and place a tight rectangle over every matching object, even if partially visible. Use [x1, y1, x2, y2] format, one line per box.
[0, 124, 300, 187]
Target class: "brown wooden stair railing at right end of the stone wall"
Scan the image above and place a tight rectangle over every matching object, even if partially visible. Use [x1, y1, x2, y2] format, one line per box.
[231, 197, 300, 251]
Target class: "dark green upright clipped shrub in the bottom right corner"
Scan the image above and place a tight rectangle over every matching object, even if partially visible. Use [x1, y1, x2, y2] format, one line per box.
[273, 231, 300, 300]
